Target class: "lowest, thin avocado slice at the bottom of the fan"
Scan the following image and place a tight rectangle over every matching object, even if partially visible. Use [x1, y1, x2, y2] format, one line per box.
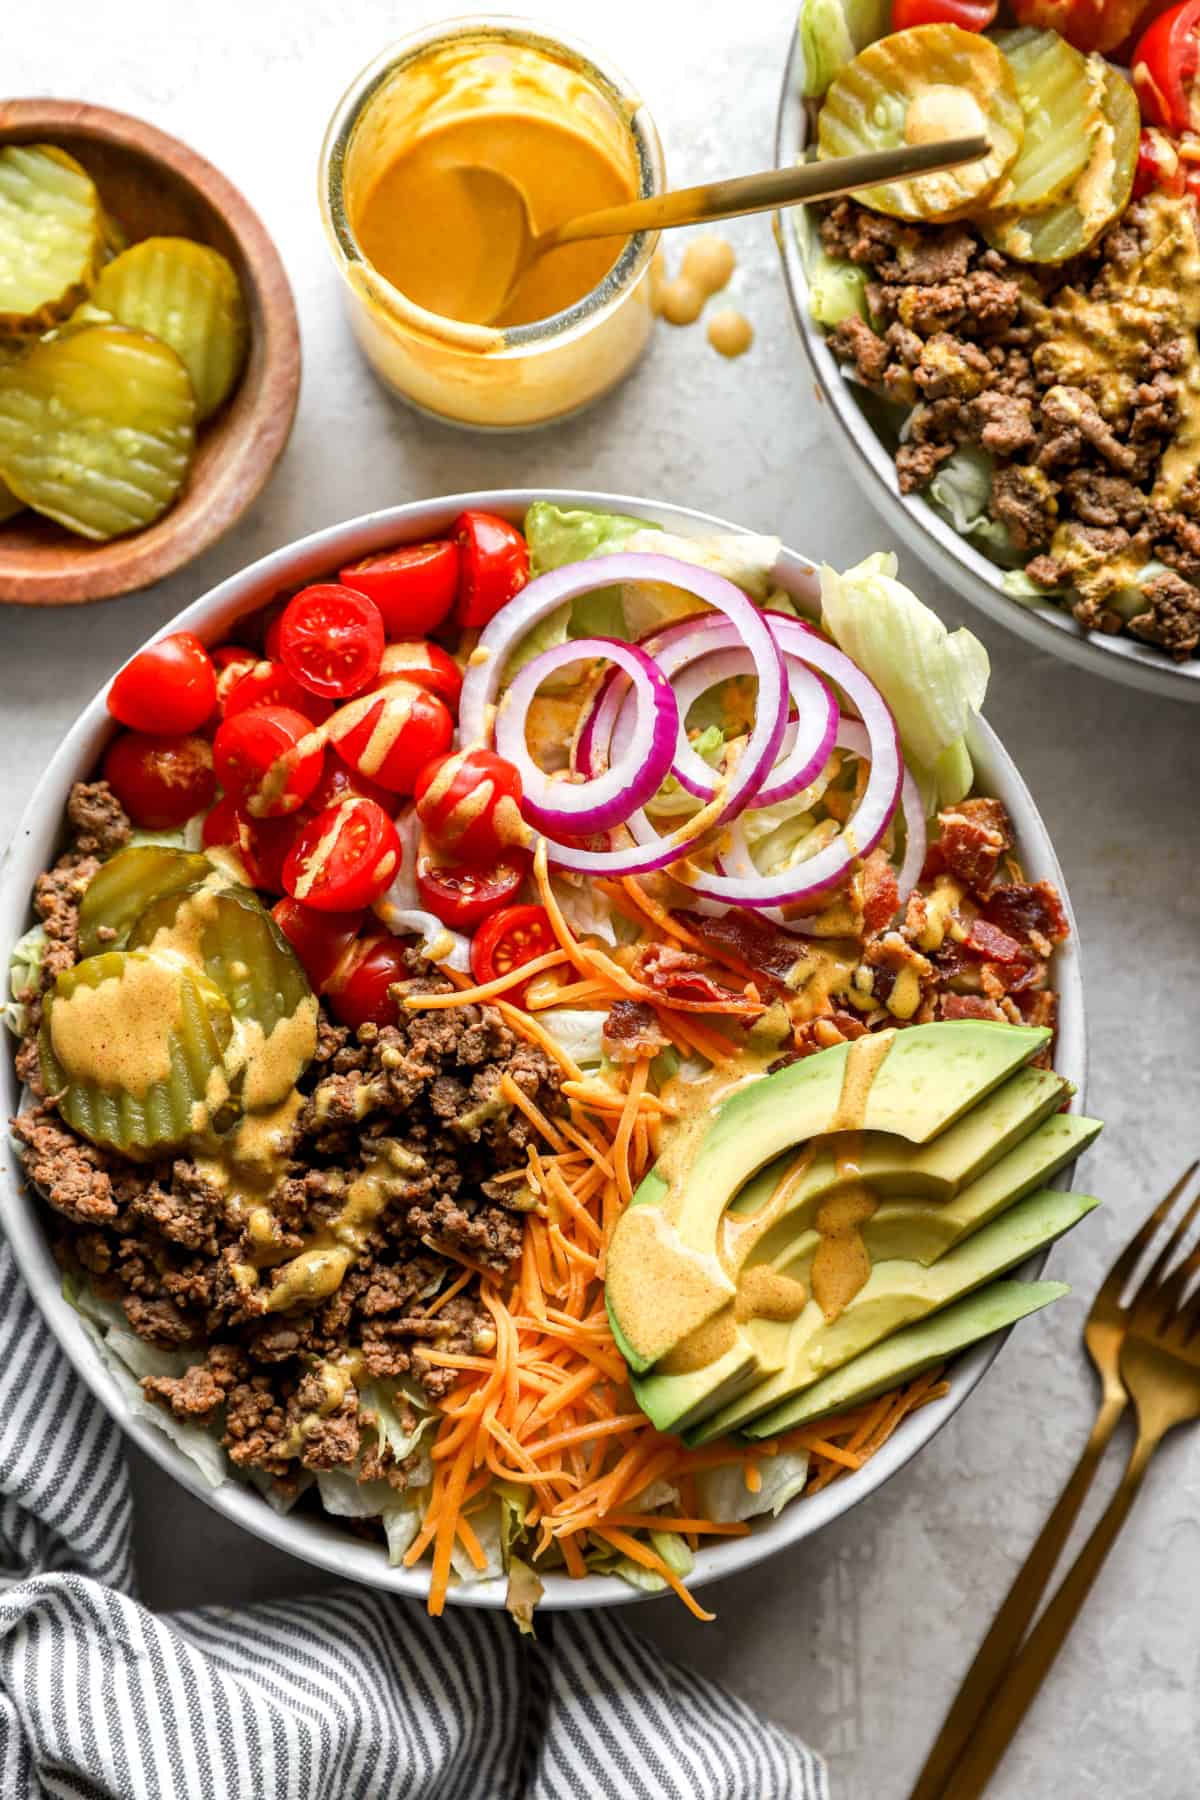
[747, 1282, 1070, 1438]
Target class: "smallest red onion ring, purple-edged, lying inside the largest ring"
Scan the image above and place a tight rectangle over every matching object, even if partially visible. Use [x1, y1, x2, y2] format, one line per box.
[495, 637, 678, 837]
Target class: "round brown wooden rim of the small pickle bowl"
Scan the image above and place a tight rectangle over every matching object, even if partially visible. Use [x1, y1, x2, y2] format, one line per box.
[0, 95, 300, 607]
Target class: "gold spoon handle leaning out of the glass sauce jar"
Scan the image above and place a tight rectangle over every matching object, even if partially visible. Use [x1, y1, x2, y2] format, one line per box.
[538, 137, 991, 250]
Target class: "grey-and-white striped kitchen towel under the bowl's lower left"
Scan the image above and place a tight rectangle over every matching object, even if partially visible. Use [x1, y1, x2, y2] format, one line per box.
[0, 1242, 828, 1800]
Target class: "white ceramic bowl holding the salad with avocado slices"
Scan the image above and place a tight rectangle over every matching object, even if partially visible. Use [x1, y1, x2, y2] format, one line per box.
[0, 488, 1085, 1607]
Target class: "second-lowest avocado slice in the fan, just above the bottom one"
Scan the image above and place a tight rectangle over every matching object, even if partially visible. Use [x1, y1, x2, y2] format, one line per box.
[680, 1188, 1099, 1444]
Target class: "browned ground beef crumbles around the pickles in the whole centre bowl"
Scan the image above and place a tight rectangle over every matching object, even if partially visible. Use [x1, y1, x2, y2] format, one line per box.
[13, 781, 563, 1487]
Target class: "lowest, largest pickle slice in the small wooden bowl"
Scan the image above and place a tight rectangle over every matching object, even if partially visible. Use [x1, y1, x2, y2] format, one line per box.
[0, 324, 196, 538]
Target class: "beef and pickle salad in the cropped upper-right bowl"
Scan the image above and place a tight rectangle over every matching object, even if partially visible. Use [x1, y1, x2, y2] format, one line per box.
[797, 0, 1200, 662]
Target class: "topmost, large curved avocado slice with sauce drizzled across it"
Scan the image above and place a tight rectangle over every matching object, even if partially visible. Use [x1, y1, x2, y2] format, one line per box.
[604, 1019, 1051, 1373]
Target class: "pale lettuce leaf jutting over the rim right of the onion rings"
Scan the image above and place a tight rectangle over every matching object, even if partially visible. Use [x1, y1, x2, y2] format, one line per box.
[820, 551, 990, 810]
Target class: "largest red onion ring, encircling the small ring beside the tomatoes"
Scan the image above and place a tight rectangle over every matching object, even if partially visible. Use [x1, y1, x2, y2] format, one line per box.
[459, 551, 788, 875]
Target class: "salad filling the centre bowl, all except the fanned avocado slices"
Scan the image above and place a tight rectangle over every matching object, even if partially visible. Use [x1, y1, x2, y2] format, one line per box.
[7, 502, 1069, 1625]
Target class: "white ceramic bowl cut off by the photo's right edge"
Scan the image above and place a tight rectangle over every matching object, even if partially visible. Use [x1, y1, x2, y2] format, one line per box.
[775, 32, 1200, 700]
